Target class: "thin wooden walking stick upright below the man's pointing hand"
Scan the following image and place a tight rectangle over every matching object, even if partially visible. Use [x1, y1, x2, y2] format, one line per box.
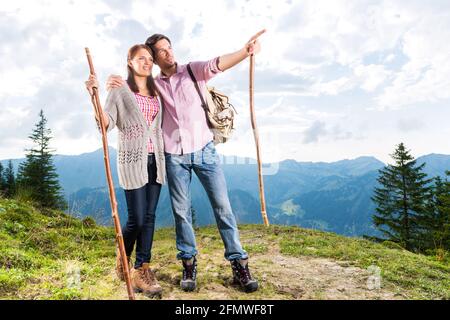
[250, 49, 269, 227]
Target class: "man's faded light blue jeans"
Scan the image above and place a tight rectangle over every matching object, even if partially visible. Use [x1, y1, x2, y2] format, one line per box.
[166, 142, 248, 260]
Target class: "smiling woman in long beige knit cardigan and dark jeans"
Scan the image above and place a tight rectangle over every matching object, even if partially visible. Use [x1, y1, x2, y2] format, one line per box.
[86, 44, 166, 296]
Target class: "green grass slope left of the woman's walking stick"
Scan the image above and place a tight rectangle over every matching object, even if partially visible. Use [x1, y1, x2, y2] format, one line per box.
[0, 199, 115, 299]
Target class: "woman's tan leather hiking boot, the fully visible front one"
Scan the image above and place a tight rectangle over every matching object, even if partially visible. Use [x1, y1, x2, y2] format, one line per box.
[131, 263, 162, 297]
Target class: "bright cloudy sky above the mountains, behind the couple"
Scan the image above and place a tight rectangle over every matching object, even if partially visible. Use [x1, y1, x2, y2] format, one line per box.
[0, 0, 450, 162]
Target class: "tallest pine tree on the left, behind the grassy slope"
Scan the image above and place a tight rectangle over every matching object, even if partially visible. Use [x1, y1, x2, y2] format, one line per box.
[17, 110, 66, 209]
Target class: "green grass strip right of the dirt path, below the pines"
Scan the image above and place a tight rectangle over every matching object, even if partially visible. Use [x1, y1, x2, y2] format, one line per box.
[272, 227, 450, 299]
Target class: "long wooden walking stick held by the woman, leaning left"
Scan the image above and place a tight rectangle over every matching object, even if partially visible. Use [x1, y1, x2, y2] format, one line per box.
[85, 48, 135, 300]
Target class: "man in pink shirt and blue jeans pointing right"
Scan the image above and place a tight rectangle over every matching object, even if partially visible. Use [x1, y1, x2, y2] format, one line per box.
[107, 30, 265, 292]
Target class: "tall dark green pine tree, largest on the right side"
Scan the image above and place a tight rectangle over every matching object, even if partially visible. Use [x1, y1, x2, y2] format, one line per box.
[372, 143, 431, 250]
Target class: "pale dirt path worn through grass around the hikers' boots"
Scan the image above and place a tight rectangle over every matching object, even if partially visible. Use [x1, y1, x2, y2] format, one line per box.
[93, 247, 403, 300]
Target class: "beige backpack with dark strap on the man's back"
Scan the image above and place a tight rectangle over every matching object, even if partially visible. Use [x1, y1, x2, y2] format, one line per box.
[187, 64, 237, 144]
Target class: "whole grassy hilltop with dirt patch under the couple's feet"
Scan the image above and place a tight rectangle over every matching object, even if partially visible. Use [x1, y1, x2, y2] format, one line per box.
[0, 199, 450, 299]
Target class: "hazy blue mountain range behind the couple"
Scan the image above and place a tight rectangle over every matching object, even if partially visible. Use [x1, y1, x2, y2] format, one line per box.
[2, 148, 450, 236]
